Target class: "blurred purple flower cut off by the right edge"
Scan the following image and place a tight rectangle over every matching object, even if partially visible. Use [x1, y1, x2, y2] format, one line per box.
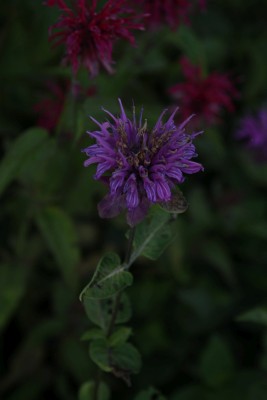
[236, 109, 267, 161]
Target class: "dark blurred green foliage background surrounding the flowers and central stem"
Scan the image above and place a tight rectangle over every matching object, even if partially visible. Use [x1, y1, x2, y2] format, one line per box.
[0, 0, 267, 400]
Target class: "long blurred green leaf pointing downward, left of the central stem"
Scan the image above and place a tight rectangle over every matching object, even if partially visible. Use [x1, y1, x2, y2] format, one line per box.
[36, 207, 80, 287]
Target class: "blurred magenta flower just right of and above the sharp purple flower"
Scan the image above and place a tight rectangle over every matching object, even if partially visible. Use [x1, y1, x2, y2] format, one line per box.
[169, 57, 238, 123]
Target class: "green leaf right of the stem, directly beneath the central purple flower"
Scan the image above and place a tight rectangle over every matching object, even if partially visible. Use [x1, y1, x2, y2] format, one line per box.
[129, 208, 173, 265]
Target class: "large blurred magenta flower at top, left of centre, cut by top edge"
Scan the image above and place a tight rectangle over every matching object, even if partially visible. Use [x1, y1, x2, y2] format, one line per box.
[46, 0, 146, 77]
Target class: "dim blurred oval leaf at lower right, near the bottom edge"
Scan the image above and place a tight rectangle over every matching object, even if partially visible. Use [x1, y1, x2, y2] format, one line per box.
[198, 336, 235, 387]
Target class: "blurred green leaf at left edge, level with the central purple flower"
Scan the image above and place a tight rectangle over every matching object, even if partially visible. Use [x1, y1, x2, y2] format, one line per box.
[0, 128, 48, 195]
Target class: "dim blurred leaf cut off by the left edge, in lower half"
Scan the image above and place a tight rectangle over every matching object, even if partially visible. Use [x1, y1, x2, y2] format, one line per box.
[0, 264, 25, 330]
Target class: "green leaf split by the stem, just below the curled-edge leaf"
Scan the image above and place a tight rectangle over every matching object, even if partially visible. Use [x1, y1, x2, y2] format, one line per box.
[83, 293, 132, 330]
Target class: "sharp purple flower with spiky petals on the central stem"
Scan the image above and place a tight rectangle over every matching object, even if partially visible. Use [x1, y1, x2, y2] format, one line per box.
[82, 100, 203, 226]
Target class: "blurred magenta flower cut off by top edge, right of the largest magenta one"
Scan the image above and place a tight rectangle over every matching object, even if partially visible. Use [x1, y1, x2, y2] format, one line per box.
[135, 0, 206, 29]
